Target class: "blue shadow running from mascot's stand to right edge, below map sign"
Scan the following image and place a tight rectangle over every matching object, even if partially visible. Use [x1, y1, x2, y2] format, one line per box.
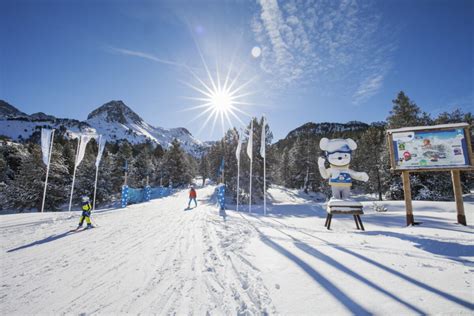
[363, 231, 474, 265]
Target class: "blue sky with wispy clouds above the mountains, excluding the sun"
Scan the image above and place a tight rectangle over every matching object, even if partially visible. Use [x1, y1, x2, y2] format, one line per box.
[0, 0, 474, 140]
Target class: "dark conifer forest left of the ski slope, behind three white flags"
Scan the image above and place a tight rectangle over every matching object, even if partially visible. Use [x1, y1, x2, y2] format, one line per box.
[0, 129, 197, 210]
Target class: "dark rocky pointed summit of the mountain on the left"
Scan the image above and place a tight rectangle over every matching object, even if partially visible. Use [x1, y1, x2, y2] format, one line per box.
[87, 100, 143, 124]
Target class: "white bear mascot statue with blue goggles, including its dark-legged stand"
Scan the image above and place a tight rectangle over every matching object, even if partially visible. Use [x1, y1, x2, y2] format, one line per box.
[318, 138, 369, 230]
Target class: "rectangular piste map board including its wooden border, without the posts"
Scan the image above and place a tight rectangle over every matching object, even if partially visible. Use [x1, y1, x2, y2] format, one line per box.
[388, 124, 472, 171]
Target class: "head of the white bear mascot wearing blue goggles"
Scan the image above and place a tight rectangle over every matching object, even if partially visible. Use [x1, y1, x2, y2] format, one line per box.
[319, 138, 357, 167]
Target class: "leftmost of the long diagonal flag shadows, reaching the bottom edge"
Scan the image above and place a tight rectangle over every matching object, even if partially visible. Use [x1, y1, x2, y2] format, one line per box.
[260, 233, 371, 315]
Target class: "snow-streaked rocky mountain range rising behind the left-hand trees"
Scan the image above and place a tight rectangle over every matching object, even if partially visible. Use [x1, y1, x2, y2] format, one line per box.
[0, 100, 206, 156]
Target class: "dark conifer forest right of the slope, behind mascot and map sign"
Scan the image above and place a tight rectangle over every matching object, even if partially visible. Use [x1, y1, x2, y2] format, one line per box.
[199, 92, 474, 201]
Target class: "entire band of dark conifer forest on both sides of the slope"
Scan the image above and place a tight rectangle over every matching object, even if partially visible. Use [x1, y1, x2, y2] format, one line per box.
[0, 92, 474, 210]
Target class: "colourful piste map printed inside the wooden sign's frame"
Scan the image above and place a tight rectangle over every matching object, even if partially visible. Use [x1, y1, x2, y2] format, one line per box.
[392, 128, 470, 169]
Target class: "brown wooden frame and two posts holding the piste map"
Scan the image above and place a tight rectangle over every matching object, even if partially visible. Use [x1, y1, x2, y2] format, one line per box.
[387, 123, 474, 226]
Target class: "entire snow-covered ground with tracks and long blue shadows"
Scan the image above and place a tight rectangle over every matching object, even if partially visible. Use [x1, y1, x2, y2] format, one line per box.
[0, 186, 474, 315]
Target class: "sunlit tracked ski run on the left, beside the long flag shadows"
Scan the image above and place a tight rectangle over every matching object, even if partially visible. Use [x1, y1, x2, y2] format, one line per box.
[0, 187, 275, 315]
